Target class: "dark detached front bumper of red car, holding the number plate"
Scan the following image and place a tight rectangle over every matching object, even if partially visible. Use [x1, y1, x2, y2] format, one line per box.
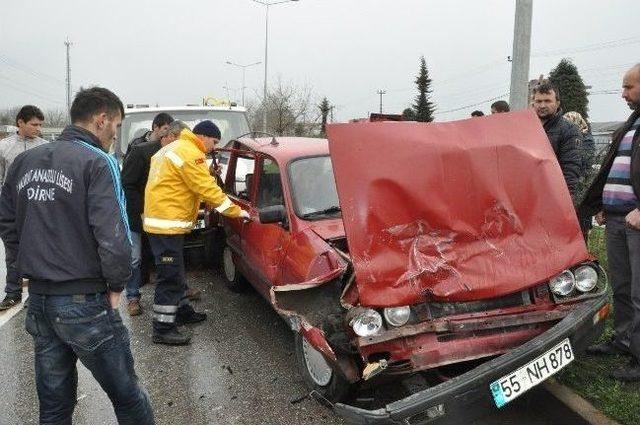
[333, 295, 607, 425]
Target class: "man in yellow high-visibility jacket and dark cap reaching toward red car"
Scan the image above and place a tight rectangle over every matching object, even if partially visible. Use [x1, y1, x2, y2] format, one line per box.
[143, 120, 249, 345]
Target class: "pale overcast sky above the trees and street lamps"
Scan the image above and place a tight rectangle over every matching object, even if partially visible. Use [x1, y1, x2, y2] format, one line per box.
[0, 0, 640, 121]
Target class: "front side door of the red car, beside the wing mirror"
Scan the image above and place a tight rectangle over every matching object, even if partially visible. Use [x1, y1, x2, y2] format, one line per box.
[242, 156, 291, 296]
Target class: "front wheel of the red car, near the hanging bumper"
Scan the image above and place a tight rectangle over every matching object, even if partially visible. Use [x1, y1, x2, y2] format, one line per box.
[295, 332, 353, 403]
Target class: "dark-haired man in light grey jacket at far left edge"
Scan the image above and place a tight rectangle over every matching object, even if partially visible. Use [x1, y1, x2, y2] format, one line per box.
[0, 105, 48, 311]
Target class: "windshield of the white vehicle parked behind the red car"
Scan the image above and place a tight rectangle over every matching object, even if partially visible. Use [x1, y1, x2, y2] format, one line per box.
[119, 110, 250, 153]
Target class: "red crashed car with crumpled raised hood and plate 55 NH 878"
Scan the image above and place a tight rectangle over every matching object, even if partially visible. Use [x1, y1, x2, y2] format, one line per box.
[214, 111, 609, 424]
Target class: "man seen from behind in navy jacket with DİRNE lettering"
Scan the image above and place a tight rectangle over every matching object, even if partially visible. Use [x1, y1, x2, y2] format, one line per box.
[0, 87, 154, 424]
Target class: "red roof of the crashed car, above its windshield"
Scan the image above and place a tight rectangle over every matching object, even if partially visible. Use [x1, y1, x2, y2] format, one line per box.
[238, 137, 329, 164]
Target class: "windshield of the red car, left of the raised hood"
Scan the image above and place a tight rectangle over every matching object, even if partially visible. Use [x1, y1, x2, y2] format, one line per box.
[289, 155, 342, 220]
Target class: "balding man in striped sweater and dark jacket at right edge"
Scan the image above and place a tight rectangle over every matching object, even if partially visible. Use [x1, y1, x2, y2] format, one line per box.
[580, 64, 640, 381]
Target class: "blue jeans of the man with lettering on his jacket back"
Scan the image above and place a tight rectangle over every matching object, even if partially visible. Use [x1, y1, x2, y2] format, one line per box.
[25, 293, 154, 425]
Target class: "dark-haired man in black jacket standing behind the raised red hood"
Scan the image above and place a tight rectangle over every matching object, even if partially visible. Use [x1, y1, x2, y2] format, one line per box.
[533, 82, 582, 196]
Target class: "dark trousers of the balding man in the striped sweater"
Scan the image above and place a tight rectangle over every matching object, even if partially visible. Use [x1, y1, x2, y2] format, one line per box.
[605, 214, 640, 359]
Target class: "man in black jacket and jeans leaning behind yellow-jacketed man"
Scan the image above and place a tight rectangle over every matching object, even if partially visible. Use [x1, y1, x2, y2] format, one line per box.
[122, 121, 188, 316]
